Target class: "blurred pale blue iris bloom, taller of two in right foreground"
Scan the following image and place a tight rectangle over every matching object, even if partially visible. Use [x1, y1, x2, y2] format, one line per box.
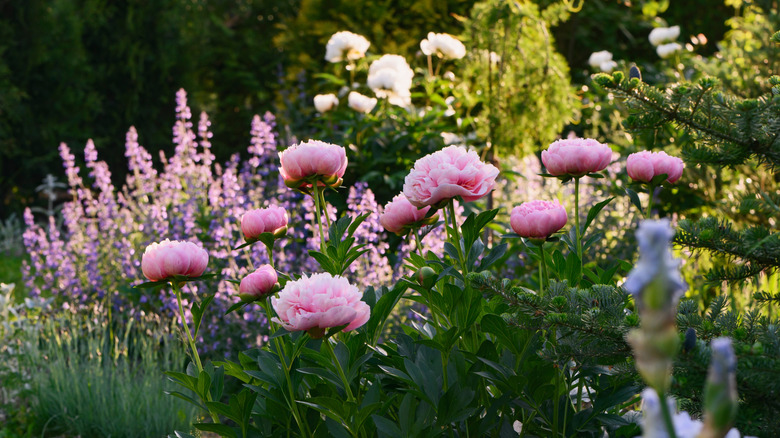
[623, 219, 688, 311]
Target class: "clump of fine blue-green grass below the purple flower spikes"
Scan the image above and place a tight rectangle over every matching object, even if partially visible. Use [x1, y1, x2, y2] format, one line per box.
[23, 315, 194, 437]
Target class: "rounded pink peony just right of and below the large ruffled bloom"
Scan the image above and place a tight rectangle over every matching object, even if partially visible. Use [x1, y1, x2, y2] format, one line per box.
[509, 200, 569, 239]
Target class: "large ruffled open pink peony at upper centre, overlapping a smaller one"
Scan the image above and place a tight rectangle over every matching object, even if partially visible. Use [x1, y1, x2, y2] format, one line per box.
[404, 146, 498, 207]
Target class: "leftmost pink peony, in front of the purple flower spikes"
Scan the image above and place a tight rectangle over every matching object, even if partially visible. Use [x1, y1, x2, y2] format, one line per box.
[141, 239, 209, 281]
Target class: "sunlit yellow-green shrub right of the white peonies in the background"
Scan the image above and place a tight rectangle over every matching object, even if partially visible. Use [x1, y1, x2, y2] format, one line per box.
[457, 0, 574, 156]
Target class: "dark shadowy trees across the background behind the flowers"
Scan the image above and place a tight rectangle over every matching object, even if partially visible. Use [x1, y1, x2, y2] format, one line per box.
[0, 0, 738, 218]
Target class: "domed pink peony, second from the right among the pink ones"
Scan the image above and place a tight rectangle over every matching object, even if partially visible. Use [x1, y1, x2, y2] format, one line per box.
[542, 138, 612, 176]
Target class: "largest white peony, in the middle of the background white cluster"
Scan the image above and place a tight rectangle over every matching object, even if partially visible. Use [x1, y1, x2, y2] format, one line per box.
[367, 55, 414, 107]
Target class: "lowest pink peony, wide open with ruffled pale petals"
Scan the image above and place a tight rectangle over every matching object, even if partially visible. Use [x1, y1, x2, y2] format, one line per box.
[271, 273, 371, 338]
